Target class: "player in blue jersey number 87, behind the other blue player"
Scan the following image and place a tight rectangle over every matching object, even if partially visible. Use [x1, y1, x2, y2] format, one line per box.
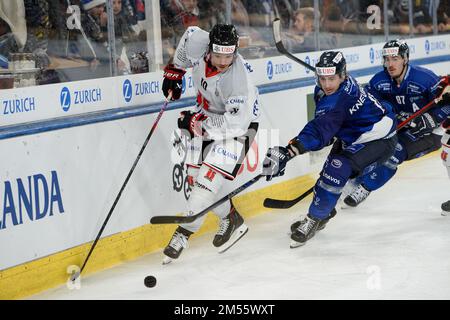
[344, 40, 450, 207]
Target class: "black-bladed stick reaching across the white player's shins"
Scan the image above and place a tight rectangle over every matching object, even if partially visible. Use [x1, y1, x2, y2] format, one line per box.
[150, 174, 265, 224]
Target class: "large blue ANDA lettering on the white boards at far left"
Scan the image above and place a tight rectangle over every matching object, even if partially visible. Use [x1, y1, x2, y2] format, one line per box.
[0, 171, 64, 232]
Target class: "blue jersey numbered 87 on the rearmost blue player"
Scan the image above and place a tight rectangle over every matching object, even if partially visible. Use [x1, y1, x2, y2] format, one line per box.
[366, 65, 450, 122]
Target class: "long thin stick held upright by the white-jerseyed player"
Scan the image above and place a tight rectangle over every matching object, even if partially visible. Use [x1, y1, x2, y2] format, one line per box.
[71, 94, 172, 281]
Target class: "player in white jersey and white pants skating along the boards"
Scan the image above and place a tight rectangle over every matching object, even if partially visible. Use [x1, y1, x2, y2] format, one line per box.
[163, 24, 259, 264]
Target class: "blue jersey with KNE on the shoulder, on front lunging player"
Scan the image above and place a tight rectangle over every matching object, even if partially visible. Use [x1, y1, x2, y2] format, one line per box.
[297, 76, 396, 151]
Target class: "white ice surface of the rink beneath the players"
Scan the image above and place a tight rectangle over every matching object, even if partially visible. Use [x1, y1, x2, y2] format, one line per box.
[31, 154, 450, 300]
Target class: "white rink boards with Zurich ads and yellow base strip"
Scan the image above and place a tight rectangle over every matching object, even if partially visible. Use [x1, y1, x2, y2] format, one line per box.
[0, 36, 450, 299]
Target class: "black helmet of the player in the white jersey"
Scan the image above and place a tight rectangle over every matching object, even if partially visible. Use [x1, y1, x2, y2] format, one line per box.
[209, 24, 239, 54]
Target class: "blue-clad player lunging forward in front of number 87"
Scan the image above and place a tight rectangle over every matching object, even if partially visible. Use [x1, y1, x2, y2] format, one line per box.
[263, 51, 397, 248]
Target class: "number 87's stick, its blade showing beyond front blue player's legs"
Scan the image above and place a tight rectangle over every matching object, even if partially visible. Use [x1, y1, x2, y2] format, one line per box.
[264, 76, 450, 209]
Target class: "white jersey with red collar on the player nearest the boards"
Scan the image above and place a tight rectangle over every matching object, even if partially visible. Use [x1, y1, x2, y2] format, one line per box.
[174, 27, 260, 140]
